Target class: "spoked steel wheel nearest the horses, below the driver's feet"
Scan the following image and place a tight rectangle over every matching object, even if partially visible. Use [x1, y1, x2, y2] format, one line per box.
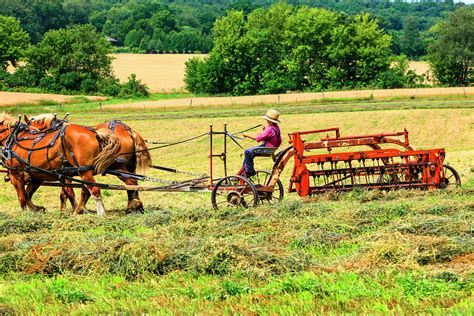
[211, 176, 258, 210]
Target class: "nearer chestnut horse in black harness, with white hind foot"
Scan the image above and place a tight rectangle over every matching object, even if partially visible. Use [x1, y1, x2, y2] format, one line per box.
[0, 114, 120, 215]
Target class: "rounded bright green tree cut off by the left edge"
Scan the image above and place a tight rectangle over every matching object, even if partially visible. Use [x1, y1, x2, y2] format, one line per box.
[0, 15, 30, 70]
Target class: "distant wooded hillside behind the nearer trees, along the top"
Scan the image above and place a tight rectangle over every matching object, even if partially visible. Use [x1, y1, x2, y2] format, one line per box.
[0, 0, 470, 55]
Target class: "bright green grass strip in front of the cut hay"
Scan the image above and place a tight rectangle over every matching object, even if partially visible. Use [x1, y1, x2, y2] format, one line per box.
[0, 271, 473, 314]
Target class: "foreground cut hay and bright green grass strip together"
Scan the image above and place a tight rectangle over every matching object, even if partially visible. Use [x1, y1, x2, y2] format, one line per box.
[0, 190, 474, 314]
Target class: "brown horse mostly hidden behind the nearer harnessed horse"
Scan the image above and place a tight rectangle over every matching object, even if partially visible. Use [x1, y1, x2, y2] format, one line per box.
[25, 114, 151, 211]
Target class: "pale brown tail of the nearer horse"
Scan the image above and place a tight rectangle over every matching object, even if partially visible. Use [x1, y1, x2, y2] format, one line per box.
[94, 130, 120, 174]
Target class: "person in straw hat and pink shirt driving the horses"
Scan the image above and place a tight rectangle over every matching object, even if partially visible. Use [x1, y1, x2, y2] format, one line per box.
[239, 110, 282, 178]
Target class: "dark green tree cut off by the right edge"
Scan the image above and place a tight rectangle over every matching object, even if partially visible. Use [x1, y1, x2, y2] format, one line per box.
[429, 7, 474, 86]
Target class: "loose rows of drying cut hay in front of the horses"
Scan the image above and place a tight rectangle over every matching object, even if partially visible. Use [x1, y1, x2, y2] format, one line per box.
[0, 191, 474, 279]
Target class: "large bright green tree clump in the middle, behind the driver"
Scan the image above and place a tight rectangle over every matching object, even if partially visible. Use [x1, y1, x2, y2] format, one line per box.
[186, 3, 391, 94]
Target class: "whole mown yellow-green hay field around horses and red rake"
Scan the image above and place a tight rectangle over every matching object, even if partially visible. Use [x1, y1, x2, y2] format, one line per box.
[0, 98, 474, 314]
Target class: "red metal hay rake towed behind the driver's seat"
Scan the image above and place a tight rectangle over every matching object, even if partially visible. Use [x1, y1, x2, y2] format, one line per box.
[268, 128, 461, 197]
